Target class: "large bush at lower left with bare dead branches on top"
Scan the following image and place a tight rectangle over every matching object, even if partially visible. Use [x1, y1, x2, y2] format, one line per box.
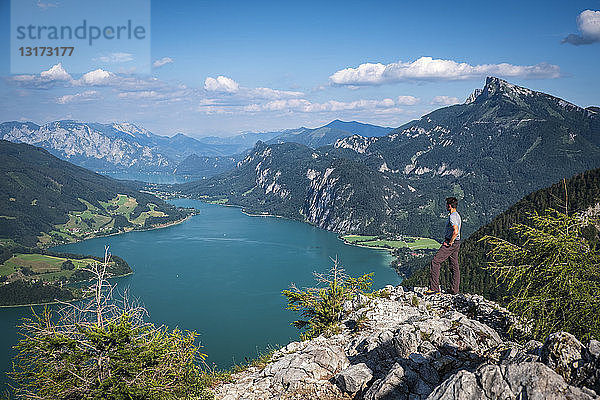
[11, 247, 212, 400]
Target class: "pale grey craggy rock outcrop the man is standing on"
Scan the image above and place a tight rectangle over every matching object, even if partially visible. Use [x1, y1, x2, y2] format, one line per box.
[216, 286, 600, 400]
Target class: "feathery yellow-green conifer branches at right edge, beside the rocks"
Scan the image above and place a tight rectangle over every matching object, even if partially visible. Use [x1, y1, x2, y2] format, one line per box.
[481, 209, 600, 340]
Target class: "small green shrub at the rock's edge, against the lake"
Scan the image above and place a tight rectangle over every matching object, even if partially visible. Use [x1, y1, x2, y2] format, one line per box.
[282, 259, 373, 340]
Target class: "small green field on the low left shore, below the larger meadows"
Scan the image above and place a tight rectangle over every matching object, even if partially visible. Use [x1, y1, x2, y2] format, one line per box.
[0, 253, 106, 282]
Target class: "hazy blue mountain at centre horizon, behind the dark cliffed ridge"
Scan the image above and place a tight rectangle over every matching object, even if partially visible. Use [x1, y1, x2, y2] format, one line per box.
[267, 119, 392, 149]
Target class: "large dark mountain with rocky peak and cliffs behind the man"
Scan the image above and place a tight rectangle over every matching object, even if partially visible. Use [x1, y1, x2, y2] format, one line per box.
[183, 77, 600, 237]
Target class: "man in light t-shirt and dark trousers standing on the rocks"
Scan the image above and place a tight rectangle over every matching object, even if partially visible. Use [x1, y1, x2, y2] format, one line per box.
[425, 197, 462, 294]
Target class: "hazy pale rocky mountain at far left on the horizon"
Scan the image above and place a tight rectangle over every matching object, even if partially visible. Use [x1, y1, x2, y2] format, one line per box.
[0, 121, 230, 171]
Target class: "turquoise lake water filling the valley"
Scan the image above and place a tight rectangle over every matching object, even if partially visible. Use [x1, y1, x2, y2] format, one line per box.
[0, 199, 401, 390]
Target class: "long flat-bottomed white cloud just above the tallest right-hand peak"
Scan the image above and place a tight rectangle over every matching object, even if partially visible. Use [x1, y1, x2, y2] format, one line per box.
[329, 57, 560, 86]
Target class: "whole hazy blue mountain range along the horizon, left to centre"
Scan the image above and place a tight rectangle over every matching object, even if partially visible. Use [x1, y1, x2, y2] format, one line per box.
[0, 120, 389, 177]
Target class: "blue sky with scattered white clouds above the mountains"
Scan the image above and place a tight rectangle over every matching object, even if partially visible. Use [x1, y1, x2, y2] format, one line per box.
[0, 0, 600, 137]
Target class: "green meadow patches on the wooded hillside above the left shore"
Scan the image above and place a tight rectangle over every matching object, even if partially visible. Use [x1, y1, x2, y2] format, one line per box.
[50, 194, 167, 242]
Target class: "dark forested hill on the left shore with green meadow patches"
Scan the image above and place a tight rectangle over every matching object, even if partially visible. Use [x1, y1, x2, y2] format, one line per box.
[0, 140, 187, 246]
